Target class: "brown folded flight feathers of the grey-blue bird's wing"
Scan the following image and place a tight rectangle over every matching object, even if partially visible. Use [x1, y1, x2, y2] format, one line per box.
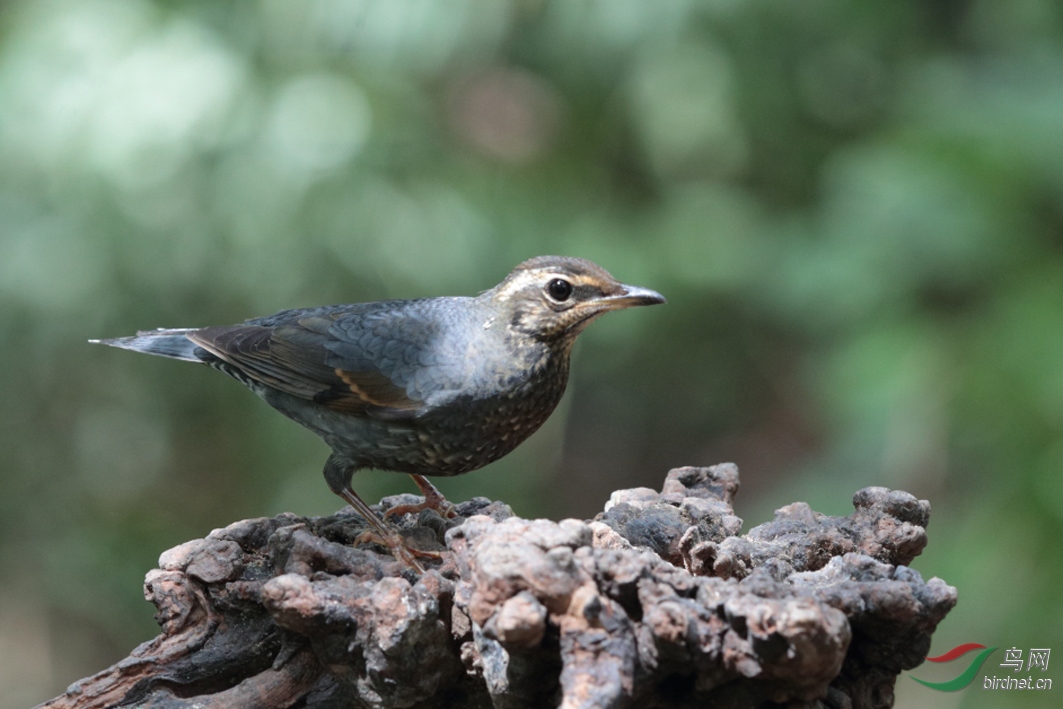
[187, 321, 424, 419]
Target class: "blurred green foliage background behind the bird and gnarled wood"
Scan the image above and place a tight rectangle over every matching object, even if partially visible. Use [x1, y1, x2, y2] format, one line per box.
[0, 0, 1063, 709]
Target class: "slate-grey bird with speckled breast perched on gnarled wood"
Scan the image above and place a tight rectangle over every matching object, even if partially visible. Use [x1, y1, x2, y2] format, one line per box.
[90, 256, 665, 571]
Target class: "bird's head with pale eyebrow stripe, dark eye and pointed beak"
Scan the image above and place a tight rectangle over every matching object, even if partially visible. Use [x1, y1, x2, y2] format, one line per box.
[484, 256, 664, 344]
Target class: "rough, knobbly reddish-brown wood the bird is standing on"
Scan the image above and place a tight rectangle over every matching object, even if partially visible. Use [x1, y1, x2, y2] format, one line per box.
[40, 463, 956, 709]
